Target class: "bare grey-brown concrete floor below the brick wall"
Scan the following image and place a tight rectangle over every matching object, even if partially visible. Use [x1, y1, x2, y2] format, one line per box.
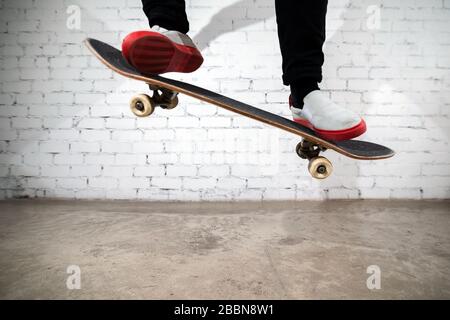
[0, 200, 450, 299]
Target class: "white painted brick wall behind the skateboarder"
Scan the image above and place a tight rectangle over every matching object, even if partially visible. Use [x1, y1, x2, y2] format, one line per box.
[0, 0, 450, 201]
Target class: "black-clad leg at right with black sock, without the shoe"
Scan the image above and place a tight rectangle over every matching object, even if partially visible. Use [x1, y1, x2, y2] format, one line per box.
[275, 0, 328, 108]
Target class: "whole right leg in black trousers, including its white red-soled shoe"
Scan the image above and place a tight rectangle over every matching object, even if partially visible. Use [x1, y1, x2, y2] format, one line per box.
[275, 0, 366, 140]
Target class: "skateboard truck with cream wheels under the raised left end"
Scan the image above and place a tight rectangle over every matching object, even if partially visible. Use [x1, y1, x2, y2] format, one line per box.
[130, 84, 178, 117]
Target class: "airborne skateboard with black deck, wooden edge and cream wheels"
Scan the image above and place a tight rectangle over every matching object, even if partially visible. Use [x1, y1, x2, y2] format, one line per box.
[85, 38, 395, 179]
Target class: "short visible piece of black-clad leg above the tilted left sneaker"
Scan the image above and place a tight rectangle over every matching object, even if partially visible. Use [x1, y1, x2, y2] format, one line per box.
[142, 0, 189, 34]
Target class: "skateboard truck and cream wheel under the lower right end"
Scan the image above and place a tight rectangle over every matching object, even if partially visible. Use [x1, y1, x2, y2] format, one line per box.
[295, 139, 333, 179]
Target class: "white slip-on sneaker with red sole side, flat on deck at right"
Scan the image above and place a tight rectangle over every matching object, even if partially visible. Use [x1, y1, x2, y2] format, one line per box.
[289, 90, 366, 141]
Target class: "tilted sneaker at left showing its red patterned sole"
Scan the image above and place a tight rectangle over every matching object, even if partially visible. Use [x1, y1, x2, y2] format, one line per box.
[122, 26, 203, 74]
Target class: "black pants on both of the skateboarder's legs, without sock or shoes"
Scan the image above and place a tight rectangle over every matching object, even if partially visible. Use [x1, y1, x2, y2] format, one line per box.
[142, 0, 328, 85]
